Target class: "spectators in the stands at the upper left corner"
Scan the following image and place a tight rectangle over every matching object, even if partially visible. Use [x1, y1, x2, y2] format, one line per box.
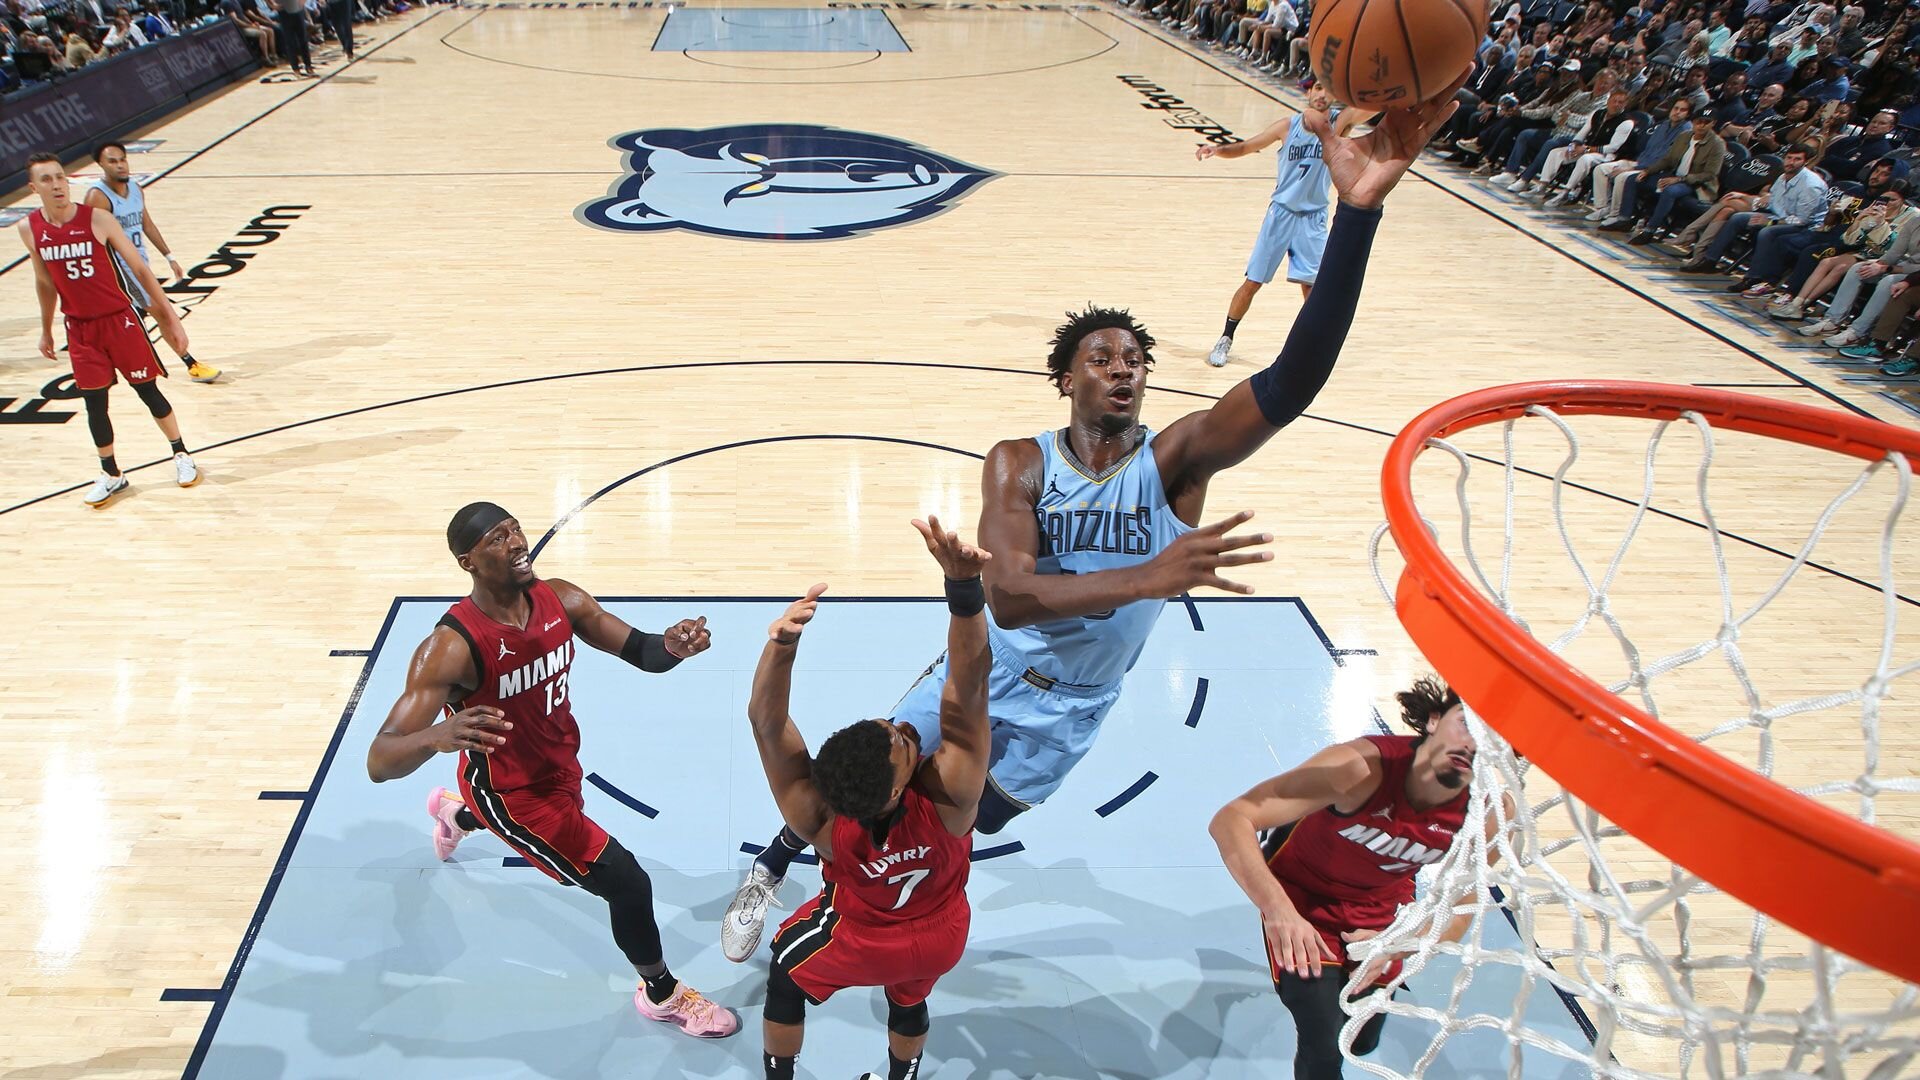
[0, 0, 418, 92]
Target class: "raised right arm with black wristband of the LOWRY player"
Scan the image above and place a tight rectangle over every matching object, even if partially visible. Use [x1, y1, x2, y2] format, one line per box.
[914, 513, 993, 836]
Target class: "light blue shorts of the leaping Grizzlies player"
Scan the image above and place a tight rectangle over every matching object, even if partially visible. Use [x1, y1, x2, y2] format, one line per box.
[893, 641, 1119, 807]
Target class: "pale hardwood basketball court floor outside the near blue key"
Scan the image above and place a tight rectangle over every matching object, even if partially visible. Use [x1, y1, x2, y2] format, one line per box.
[0, 2, 1920, 1080]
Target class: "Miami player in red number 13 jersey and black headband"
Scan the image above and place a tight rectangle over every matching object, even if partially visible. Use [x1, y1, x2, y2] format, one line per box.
[367, 502, 739, 1038]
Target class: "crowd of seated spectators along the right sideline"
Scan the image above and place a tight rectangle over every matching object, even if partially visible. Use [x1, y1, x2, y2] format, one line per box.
[1121, 0, 1920, 379]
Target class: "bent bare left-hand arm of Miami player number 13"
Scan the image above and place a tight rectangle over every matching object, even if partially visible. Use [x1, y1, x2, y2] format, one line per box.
[367, 626, 513, 784]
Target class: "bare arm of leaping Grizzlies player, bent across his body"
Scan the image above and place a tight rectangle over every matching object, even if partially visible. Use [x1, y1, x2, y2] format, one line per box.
[979, 438, 1273, 628]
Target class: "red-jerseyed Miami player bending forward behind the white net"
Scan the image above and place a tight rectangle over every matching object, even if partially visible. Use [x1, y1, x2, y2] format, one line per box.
[1210, 678, 1513, 1080]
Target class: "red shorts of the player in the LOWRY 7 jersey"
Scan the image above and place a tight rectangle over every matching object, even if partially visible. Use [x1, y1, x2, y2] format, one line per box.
[774, 880, 973, 1009]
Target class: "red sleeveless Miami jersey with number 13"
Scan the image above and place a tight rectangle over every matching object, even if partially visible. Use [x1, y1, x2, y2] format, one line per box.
[440, 580, 580, 792]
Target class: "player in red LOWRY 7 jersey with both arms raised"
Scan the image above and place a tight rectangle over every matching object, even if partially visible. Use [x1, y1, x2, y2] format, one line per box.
[747, 515, 991, 1080]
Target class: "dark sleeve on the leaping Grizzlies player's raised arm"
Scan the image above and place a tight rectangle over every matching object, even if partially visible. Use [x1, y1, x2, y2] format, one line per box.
[1248, 204, 1380, 427]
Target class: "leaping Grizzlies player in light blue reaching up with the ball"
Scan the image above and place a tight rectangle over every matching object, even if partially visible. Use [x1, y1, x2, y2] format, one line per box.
[720, 75, 1465, 961]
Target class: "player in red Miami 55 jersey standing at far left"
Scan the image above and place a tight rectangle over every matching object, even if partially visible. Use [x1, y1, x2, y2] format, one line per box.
[19, 154, 200, 509]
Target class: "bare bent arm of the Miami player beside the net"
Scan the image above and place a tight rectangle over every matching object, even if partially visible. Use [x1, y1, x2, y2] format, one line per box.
[1208, 738, 1380, 976]
